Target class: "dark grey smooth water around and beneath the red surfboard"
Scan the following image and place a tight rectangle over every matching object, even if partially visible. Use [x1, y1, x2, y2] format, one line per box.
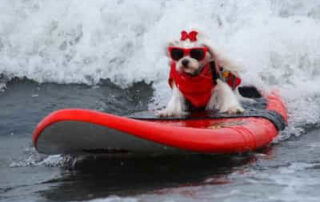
[0, 80, 320, 201]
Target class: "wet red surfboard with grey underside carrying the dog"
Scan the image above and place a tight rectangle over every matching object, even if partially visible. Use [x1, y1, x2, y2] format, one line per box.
[33, 87, 287, 155]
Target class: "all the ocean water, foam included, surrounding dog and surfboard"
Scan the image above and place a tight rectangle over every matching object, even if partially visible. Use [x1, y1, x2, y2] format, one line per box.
[0, 0, 320, 202]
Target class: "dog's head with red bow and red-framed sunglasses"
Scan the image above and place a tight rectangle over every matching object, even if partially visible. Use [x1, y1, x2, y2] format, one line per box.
[167, 30, 214, 76]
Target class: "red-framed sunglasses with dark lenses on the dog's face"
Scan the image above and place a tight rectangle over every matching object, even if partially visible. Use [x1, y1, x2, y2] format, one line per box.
[168, 47, 208, 61]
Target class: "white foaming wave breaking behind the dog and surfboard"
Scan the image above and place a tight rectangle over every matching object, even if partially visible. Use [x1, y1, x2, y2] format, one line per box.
[0, 0, 320, 137]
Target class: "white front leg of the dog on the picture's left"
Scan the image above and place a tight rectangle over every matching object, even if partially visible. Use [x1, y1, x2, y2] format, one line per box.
[157, 84, 188, 117]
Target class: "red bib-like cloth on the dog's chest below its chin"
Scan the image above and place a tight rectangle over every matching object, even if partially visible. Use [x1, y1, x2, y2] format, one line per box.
[169, 61, 214, 107]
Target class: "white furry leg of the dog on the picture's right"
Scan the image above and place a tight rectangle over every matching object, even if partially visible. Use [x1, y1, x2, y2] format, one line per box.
[206, 79, 244, 114]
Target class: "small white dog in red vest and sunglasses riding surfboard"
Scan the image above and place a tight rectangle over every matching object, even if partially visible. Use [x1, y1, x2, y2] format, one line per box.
[158, 30, 244, 117]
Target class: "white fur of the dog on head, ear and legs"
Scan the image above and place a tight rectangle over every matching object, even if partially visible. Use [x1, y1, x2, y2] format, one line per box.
[158, 30, 244, 117]
